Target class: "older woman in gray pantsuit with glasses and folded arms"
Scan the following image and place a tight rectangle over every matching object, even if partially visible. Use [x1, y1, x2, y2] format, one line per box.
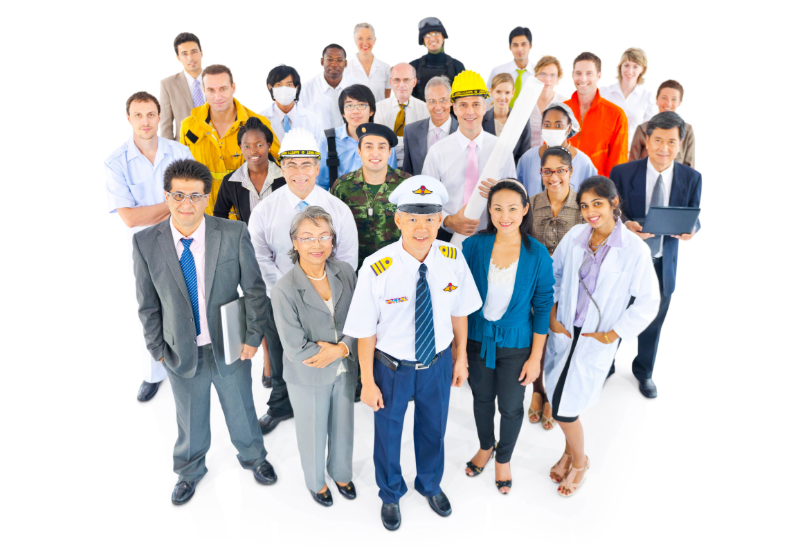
[272, 206, 358, 506]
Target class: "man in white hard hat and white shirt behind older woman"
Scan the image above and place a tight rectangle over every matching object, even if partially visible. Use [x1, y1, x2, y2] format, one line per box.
[248, 129, 358, 434]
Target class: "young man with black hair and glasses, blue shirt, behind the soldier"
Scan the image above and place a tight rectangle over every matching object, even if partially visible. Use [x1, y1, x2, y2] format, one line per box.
[317, 84, 397, 190]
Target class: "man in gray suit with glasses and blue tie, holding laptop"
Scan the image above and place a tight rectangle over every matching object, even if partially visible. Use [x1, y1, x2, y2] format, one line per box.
[133, 159, 278, 504]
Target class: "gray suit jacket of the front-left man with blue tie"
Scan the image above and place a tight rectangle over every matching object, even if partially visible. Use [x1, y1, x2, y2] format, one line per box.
[133, 215, 267, 378]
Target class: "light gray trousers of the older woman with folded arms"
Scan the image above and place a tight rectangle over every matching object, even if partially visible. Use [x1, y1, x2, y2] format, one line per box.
[286, 372, 355, 493]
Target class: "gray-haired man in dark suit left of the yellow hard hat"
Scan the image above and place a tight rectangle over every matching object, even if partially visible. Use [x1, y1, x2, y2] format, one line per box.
[403, 76, 458, 176]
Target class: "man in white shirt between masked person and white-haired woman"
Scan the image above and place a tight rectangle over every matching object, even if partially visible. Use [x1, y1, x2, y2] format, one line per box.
[300, 44, 355, 130]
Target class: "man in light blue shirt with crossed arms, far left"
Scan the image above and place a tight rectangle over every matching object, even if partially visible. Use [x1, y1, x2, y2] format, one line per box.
[105, 92, 192, 401]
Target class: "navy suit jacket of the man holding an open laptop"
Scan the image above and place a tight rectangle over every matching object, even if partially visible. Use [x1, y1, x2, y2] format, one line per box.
[611, 158, 703, 296]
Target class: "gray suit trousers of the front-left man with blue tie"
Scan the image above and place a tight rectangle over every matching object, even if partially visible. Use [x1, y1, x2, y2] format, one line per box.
[167, 344, 267, 481]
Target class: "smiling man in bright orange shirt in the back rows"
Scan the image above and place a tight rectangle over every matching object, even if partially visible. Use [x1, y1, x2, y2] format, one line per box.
[564, 52, 628, 177]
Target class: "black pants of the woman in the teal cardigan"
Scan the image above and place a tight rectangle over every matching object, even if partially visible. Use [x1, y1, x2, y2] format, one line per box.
[467, 340, 531, 464]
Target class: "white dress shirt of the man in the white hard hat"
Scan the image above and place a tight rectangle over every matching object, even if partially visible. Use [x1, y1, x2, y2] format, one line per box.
[247, 184, 358, 296]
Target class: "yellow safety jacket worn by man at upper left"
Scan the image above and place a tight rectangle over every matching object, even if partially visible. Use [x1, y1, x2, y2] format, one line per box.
[180, 98, 281, 215]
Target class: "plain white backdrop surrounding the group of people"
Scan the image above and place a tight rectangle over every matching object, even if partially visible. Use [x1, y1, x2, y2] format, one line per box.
[0, 0, 800, 548]
